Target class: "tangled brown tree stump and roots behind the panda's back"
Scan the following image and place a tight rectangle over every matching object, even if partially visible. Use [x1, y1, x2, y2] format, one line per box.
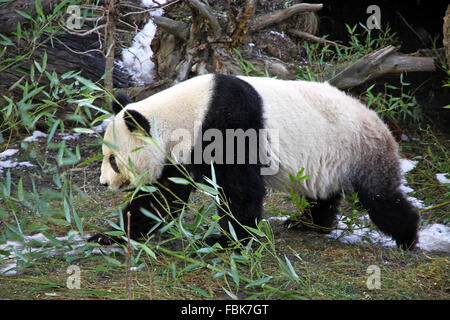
[149, 0, 322, 83]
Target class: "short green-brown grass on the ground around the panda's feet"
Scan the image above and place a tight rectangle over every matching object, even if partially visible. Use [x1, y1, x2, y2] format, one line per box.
[0, 125, 450, 300]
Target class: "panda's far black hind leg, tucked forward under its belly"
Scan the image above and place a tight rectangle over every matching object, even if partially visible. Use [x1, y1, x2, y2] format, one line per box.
[285, 193, 342, 233]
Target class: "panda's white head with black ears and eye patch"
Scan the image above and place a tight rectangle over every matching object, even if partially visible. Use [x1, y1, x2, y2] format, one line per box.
[100, 95, 165, 190]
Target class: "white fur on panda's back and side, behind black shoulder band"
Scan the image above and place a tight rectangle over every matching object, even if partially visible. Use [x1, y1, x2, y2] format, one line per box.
[240, 77, 395, 198]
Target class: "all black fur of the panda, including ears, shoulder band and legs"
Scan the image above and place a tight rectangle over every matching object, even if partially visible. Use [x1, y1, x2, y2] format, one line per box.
[90, 74, 418, 249]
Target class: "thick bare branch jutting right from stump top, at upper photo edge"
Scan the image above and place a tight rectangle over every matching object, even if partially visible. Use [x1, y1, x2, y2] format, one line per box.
[250, 3, 323, 32]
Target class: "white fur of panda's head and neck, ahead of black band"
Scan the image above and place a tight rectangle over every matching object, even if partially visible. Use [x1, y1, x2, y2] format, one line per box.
[100, 75, 213, 190]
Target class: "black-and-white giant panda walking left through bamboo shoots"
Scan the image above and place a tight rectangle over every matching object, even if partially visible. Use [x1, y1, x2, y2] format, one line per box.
[90, 74, 419, 249]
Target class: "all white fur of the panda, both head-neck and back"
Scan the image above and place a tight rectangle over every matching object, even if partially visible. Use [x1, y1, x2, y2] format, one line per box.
[100, 74, 397, 198]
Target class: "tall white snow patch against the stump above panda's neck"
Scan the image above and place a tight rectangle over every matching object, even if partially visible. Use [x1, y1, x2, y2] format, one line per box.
[118, 0, 167, 85]
